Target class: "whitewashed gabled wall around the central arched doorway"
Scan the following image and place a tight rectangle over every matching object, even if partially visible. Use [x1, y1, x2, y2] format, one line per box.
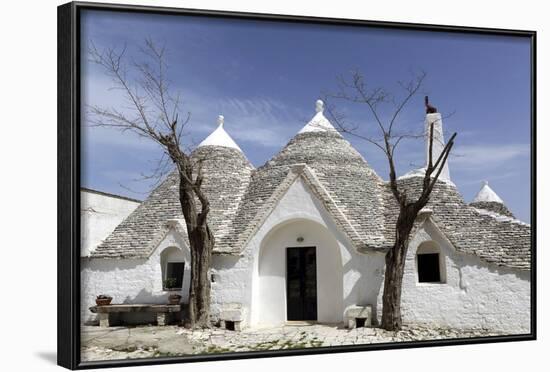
[213, 178, 383, 326]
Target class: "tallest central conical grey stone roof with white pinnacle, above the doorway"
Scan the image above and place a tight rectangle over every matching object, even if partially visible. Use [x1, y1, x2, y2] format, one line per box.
[231, 101, 386, 249]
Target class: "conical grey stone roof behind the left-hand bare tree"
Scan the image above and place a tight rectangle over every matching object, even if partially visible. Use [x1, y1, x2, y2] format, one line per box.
[92, 117, 254, 258]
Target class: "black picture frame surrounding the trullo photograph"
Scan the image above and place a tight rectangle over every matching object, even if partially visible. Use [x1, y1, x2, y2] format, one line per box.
[57, 2, 537, 369]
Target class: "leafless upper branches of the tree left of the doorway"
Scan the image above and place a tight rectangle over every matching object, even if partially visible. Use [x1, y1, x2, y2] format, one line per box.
[87, 38, 213, 216]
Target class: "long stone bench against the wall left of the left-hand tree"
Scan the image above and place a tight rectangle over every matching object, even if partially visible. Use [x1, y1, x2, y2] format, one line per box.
[90, 304, 181, 327]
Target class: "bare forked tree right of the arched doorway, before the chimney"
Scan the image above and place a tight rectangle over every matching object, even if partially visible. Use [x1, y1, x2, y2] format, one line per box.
[328, 71, 456, 330]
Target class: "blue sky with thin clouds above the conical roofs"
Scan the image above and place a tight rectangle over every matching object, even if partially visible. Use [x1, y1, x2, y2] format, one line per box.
[81, 11, 530, 221]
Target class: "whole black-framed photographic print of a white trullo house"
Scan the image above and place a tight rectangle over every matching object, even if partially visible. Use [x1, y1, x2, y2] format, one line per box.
[58, 3, 536, 369]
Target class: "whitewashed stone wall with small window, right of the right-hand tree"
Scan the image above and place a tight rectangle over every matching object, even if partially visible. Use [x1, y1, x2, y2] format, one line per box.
[378, 220, 531, 333]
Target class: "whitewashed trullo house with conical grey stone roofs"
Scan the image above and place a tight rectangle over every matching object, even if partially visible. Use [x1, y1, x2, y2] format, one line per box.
[81, 101, 531, 333]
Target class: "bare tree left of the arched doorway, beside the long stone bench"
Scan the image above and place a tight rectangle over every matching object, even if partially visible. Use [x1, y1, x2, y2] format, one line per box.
[88, 39, 214, 328]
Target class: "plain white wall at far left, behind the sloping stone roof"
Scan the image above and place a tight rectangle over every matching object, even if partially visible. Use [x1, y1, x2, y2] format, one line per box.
[80, 190, 140, 257]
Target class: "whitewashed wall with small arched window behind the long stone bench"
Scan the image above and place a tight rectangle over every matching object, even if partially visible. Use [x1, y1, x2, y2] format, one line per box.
[80, 229, 190, 323]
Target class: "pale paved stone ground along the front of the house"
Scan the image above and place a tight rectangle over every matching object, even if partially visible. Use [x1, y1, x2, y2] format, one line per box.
[81, 324, 506, 361]
